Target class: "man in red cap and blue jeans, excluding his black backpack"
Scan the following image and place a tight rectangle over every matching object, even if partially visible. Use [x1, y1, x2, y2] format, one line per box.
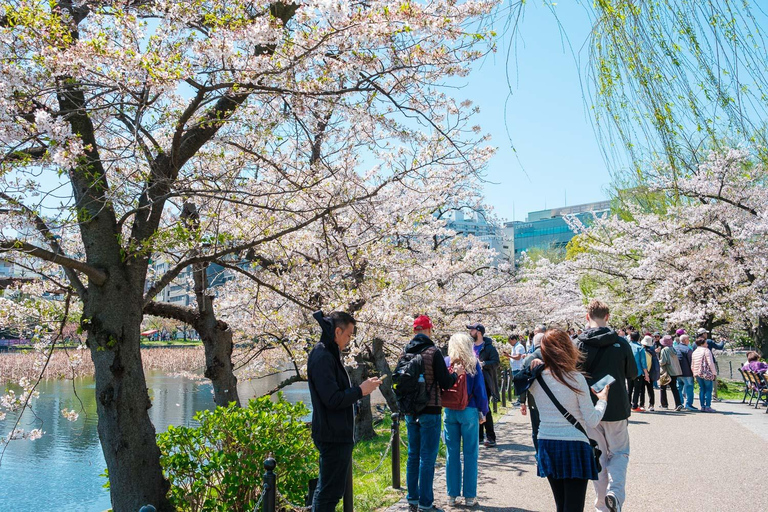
[405, 315, 465, 512]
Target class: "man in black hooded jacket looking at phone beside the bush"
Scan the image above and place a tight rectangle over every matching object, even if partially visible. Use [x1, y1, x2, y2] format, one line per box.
[307, 311, 381, 512]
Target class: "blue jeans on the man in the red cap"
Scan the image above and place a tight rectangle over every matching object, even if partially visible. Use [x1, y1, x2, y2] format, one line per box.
[405, 414, 442, 509]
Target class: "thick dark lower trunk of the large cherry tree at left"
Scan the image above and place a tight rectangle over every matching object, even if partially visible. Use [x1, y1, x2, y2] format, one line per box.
[83, 284, 173, 512]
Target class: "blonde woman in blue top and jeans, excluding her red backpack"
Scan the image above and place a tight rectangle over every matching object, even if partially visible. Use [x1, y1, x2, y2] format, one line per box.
[443, 332, 488, 507]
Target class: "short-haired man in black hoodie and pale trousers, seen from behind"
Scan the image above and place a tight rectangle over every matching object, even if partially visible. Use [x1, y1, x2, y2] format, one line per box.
[576, 300, 637, 512]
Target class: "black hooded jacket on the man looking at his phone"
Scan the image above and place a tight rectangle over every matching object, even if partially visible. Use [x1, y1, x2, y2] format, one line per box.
[307, 311, 363, 443]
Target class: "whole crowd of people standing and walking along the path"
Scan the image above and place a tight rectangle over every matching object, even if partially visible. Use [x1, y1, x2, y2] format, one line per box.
[307, 300, 768, 512]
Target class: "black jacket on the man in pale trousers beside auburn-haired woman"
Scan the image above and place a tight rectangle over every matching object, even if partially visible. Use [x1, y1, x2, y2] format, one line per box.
[576, 327, 637, 421]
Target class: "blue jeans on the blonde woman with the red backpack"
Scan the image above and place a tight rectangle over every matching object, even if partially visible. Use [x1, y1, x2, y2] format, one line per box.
[443, 407, 480, 498]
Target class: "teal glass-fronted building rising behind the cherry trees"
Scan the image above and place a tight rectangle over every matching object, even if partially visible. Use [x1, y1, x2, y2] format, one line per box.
[503, 201, 611, 261]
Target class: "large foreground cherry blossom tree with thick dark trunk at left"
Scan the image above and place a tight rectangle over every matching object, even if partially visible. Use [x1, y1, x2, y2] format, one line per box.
[0, 0, 492, 511]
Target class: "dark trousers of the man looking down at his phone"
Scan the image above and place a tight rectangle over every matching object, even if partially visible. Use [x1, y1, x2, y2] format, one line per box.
[312, 443, 354, 512]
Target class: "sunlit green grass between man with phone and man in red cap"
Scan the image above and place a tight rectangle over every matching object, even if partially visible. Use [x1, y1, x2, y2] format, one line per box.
[346, 399, 514, 512]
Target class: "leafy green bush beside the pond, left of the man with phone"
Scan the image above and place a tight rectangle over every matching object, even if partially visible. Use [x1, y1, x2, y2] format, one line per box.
[158, 395, 318, 512]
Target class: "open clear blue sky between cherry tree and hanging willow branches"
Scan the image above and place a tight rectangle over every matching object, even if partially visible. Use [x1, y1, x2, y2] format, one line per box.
[456, 0, 611, 220]
